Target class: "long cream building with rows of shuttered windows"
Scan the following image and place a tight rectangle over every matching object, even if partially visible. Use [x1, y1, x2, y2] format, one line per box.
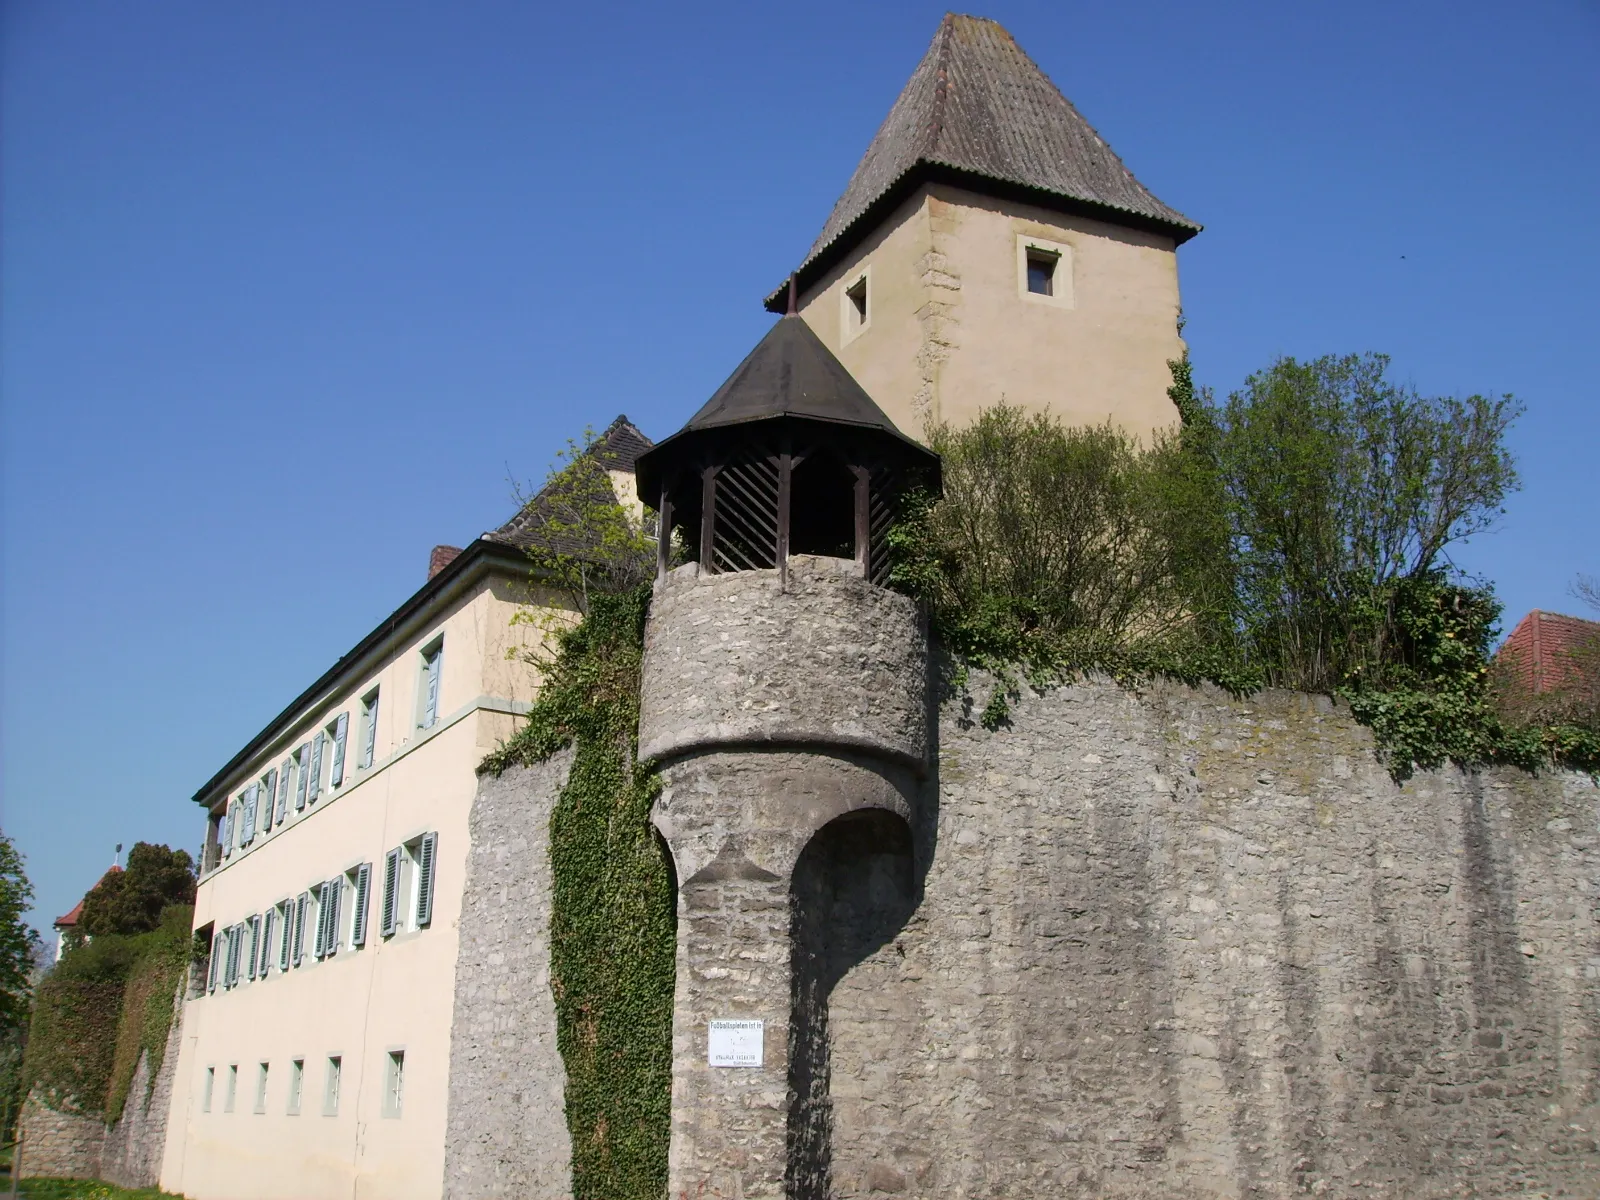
[160, 418, 650, 1200]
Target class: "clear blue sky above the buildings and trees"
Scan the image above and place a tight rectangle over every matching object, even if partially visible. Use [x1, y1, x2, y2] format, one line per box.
[0, 0, 1600, 926]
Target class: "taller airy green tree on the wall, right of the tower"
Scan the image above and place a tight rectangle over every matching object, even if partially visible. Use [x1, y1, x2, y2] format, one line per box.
[1211, 354, 1520, 691]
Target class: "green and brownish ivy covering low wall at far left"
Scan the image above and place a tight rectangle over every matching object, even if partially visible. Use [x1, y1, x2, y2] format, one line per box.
[22, 904, 194, 1123]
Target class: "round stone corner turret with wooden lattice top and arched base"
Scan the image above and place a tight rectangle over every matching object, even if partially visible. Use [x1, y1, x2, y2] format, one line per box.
[638, 315, 938, 1197]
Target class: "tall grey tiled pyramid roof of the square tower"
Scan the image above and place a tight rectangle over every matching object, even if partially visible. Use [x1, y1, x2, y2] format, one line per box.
[766, 13, 1200, 312]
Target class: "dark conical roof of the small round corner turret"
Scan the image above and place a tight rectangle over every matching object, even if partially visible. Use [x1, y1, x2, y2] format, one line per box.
[637, 314, 938, 504]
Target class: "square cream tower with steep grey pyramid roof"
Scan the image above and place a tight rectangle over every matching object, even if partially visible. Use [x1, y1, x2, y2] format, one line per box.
[768, 14, 1200, 437]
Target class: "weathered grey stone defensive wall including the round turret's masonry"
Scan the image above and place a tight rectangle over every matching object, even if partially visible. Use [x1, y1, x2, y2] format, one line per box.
[446, 560, 1600, 1200]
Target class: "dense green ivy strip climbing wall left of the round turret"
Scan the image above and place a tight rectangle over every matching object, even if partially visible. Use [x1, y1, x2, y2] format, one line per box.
[480, 584, 677, 1200]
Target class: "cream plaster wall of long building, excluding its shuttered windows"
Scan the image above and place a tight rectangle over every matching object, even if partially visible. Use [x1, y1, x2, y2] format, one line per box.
[162, 576, 566, 1200]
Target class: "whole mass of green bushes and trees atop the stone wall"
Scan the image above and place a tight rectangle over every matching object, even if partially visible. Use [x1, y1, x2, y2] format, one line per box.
[890, 355, 1600, 776]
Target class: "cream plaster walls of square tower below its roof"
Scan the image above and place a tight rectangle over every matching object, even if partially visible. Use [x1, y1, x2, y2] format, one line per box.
[800, 186, 1182, 448]
